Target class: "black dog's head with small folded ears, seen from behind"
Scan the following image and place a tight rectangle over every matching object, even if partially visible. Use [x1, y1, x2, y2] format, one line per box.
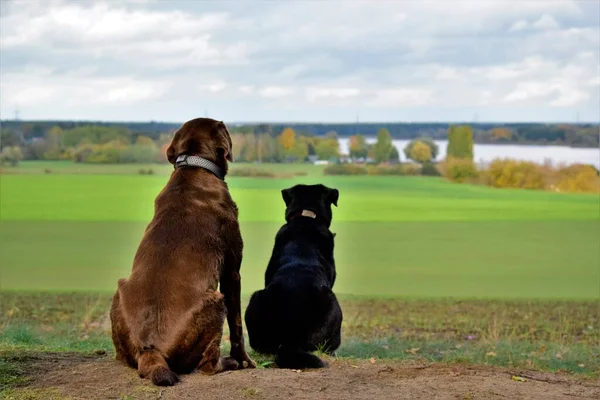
[281, 185, 340, 227]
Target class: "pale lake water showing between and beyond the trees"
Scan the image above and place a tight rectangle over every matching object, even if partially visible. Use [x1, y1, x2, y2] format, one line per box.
[340, 138, 600, 169]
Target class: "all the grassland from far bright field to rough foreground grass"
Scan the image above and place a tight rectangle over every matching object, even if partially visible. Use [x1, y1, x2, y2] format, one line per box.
[0, 162, 600, 394]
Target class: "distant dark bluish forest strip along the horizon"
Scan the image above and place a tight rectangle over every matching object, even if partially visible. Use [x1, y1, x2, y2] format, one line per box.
[0, 120, 600, 147]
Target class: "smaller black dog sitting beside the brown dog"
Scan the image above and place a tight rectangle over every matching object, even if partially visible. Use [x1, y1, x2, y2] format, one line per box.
[245, 185, 342, 369]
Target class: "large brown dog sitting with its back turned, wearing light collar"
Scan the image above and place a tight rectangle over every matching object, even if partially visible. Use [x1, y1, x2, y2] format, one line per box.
[110, 118, 256, 386]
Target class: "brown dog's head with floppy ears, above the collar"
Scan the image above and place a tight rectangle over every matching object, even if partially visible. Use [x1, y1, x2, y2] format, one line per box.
[167, 118, 233, 171]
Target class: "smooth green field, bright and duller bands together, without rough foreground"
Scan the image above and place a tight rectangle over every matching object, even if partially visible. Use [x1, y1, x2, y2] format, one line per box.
[0, 162, 600, 299]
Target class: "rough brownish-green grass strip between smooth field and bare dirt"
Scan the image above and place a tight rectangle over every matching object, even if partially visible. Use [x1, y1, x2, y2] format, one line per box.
[0, 292, 600, 379]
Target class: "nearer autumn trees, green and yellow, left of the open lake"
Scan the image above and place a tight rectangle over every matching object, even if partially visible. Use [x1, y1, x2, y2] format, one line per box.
[0, 125, 437, 165]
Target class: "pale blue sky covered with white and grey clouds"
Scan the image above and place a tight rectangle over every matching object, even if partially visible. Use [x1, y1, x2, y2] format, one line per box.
[0, 0, 600, 122]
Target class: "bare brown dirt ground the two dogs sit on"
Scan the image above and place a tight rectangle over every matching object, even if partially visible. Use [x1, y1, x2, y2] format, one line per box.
[2, 354, 600, 400]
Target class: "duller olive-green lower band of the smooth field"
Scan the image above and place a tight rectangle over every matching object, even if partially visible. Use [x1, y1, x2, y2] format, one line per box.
[0, 219, 600, 299]
